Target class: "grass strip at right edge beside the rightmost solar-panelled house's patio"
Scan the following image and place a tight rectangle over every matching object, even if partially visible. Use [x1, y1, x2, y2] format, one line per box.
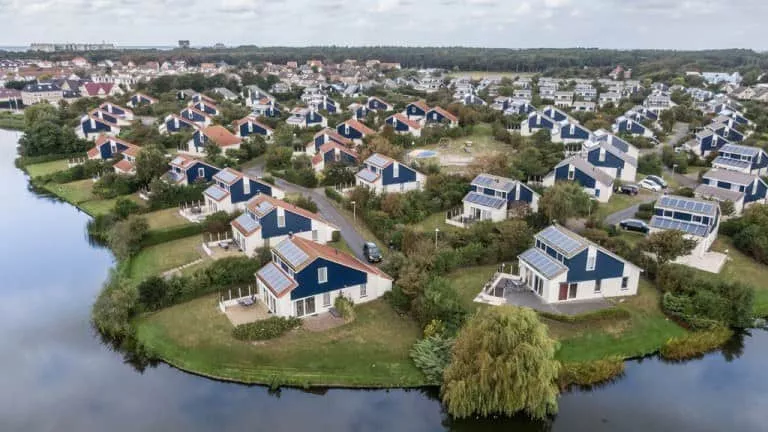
[712, 235, 768, 317]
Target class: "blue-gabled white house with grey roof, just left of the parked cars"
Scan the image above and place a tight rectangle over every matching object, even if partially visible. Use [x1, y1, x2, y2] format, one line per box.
[542, 156, 614, 203]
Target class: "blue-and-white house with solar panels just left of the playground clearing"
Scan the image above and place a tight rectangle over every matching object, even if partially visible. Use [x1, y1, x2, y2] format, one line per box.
[355, 153, 427, 194]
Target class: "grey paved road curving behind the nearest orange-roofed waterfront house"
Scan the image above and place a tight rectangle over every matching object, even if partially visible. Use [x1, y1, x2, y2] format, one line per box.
[245, 162, 368, 260]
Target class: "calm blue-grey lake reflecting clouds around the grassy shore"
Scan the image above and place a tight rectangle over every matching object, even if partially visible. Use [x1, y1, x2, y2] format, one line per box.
[0, 130, 768, 432]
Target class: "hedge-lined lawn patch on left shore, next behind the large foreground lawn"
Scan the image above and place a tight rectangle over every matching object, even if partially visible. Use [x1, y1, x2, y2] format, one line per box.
[130, 235, 202, 282]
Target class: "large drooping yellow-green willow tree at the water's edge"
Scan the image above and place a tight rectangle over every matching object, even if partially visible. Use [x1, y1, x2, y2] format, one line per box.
[443, 306, 560, 419]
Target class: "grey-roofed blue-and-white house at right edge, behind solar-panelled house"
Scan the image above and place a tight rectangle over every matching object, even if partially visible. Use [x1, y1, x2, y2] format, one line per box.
[694, 169, 768, 216]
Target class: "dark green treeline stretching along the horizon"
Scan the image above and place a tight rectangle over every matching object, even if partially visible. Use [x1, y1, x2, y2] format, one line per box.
[0, 46, 768, 74]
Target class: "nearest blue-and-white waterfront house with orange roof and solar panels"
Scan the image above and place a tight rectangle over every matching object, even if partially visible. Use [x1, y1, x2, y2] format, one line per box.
[256, 236, 392, 318]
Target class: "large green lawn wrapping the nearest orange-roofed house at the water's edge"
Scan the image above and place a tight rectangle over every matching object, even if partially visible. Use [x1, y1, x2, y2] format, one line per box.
[138, 295, 424, 387]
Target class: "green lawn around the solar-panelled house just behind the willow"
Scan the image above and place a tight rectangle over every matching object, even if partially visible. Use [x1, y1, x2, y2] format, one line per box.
[447, 265, 685, 362]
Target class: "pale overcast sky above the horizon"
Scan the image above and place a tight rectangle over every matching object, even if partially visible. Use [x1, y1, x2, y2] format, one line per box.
[0, 0, 768, 50]
